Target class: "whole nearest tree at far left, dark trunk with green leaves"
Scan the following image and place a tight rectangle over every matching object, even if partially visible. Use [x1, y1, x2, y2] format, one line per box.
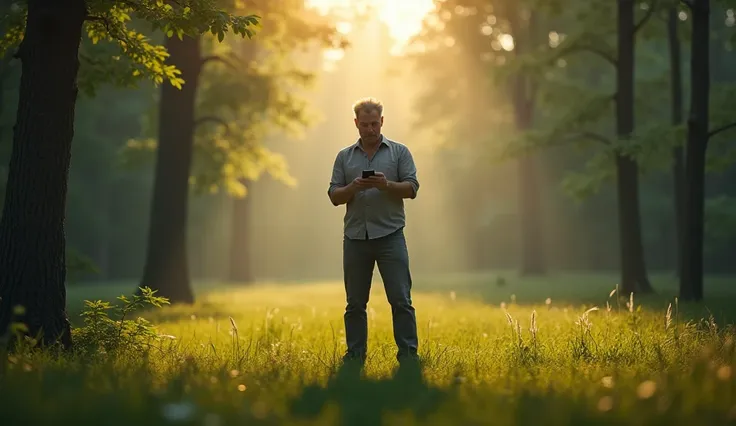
[0, 0, 257, 348]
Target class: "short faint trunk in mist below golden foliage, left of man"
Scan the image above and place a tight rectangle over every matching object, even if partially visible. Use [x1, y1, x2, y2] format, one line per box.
[229, 181, 253, 283]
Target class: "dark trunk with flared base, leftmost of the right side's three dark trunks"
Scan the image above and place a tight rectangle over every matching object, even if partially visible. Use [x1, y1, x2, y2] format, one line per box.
[616, 0, 653, 296]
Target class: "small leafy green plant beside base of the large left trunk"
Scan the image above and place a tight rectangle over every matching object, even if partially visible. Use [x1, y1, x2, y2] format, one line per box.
[72, 287, 169, 354]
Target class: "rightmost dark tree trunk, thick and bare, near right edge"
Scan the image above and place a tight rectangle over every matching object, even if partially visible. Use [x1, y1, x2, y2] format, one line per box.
[680, 0, 710, 301]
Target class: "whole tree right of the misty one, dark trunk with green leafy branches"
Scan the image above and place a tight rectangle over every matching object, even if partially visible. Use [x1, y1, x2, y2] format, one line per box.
[506, 0, 656, 293]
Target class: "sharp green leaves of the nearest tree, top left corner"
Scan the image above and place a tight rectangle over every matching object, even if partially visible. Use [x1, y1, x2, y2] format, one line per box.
[0, 0, 259, 95]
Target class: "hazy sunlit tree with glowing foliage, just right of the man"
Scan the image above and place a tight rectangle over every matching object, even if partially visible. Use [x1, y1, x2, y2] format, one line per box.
[409, 0, 549, 275]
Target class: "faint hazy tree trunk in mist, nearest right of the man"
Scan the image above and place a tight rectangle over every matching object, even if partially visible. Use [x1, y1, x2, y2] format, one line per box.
[509, 5, 547, 275]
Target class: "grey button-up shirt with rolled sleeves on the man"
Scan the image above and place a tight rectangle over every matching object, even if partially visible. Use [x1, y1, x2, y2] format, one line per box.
[327, 136, 419, 239]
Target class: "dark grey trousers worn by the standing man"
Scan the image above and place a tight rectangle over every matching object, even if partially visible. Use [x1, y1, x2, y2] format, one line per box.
[343, 228, 418, 359]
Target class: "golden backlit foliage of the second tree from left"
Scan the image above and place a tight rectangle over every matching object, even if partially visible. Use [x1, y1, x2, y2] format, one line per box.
[123, 0, 347, 197]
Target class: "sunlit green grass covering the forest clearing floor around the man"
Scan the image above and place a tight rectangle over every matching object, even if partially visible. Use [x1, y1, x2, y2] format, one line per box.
[0, 274, 736, 426]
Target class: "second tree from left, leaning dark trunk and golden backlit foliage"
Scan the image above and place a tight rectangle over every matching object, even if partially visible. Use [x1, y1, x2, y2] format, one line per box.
[122, 0, 346, 303]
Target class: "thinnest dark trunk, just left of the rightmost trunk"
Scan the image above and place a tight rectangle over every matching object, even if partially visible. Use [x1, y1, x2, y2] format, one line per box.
[667, 7, 685, 277]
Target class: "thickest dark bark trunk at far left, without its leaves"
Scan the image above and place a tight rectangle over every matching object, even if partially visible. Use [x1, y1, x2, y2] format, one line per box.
[0, 0, 87, 348]
